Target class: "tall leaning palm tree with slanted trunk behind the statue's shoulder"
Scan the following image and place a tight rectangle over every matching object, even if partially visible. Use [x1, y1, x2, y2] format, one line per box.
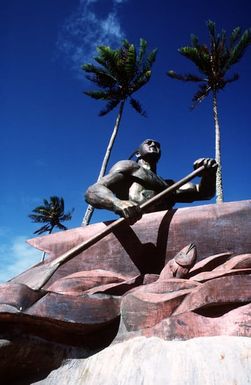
[82, 39, 157, 225]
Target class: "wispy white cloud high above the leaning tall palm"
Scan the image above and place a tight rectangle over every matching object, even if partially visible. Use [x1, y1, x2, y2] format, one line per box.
[57, 0, 127, 78]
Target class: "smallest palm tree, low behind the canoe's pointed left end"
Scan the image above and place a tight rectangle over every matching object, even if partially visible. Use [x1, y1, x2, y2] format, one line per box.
[29, 196, 74, 261]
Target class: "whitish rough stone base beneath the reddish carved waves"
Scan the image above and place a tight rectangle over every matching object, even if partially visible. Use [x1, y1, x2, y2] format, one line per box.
[35, 337, 251, 385]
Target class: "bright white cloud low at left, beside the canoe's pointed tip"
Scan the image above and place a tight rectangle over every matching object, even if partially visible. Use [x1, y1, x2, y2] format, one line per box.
[0, 235, 42, 282]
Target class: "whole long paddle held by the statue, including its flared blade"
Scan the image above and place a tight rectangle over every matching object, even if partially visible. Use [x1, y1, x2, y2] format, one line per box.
[13, 165, 206, 290]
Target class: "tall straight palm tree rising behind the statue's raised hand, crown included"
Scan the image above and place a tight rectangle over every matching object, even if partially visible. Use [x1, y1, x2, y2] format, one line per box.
[167, 20, 251, 203]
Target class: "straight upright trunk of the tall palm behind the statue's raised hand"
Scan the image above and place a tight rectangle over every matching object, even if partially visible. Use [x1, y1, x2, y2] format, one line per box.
[213, 91, 223, 203]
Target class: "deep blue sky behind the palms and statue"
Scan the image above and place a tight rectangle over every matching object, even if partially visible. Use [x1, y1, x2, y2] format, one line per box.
[0, 0, 251, 281]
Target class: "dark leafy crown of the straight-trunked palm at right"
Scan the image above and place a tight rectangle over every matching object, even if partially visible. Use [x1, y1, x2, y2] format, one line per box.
[167, 20, 251, 104]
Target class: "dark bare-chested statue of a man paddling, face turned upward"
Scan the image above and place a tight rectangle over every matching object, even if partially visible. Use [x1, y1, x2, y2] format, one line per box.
[85, 139, 217, 224]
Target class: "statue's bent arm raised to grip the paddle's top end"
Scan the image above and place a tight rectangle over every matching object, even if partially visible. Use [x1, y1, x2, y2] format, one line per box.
[175, 158, 217, 203]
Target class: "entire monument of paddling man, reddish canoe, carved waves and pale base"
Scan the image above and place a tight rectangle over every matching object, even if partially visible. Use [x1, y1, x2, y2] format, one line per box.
[0, 141, 251, 385]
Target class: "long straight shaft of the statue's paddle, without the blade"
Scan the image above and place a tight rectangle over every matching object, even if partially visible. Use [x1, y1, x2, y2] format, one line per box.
[49, 165, 205, 267]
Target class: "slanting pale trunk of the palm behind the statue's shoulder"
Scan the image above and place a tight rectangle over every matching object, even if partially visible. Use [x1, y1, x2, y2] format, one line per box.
[81, 100, 125, 226]
